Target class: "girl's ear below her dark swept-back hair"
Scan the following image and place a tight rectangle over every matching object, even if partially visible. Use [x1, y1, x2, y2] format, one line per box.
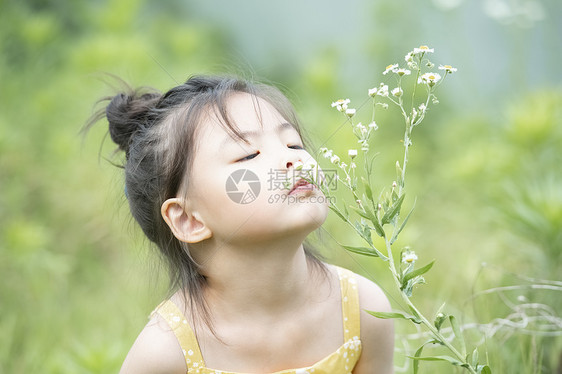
[161, 198, 213, 243]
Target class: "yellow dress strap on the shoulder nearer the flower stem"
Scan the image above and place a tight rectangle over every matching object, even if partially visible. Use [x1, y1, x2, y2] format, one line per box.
[337, 267, 361, 342]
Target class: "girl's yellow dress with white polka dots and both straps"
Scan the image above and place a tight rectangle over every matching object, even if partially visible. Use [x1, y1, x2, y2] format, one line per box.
[155, 268, 361, 374]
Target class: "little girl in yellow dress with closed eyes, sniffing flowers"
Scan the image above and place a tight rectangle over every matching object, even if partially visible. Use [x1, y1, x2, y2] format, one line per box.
[88, 76, 394, 374]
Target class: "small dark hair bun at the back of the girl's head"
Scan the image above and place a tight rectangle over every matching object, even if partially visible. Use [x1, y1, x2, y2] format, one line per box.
[105, 90, 161, 153]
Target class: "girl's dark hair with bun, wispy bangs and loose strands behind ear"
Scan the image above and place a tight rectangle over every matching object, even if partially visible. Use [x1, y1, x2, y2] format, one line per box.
[85, 76, 321, 332]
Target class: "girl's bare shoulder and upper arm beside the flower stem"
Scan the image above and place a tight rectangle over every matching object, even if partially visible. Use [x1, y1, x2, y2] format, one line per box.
[353, 275, 394, 374]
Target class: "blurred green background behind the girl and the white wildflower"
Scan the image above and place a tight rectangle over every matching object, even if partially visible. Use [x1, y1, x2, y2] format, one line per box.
[0, 0, 562, 373]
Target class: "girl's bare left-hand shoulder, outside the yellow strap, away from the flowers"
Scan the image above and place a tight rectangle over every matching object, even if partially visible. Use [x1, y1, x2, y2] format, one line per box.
[119, 313, 187, 374]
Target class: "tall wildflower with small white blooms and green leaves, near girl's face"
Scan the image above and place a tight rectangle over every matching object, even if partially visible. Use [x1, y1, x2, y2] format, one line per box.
[319, 46, 491, 374]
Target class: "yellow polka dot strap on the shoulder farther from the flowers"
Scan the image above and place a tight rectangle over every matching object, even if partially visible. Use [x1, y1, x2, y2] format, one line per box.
[153, 300, 204, 372]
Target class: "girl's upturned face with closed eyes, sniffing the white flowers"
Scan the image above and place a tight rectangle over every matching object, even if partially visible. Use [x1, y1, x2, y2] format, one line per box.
[187, 93, 328, 242]
